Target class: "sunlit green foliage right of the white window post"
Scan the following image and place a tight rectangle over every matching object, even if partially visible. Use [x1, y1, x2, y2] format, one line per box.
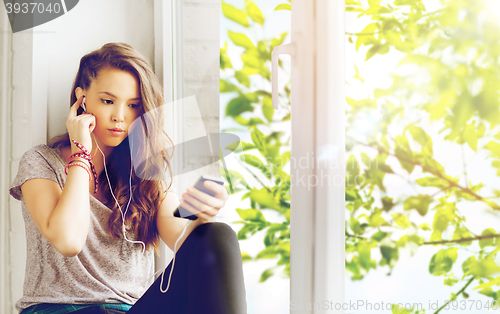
[345, 0, 500, 306]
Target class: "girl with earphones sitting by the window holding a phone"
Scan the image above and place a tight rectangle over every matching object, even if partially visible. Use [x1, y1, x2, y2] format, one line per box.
[10, 43, 246, 314]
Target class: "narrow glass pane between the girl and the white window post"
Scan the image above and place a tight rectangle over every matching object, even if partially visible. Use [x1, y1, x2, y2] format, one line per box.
[220, 0, 291, 314]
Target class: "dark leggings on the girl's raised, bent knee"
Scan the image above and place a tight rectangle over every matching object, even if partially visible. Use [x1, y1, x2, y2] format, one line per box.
[127, 222, 247, 314]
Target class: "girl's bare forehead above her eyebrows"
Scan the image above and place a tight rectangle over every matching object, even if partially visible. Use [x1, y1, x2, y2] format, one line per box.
[90, 67, 140, 99]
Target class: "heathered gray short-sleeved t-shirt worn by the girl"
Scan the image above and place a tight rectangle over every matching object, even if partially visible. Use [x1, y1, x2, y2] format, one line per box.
[10, 144, 154, 311]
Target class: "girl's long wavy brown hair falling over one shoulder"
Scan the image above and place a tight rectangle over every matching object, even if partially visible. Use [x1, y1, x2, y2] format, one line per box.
[47, 43, 173, 253]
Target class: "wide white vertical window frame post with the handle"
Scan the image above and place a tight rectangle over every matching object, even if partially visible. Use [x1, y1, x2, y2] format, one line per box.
[273, 0, 345, 313]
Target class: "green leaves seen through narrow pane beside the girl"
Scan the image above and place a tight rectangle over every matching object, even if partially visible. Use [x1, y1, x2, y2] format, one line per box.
[220, 0, 291, 282]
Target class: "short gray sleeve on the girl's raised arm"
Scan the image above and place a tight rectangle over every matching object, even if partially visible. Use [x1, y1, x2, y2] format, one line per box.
[9, 145, 58, 200]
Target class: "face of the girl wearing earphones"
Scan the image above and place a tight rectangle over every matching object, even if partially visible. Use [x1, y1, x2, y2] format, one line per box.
[76, 67, 142, 147]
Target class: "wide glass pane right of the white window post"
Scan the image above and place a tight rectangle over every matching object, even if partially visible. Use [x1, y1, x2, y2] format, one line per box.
[345, 0, 500, 313]
